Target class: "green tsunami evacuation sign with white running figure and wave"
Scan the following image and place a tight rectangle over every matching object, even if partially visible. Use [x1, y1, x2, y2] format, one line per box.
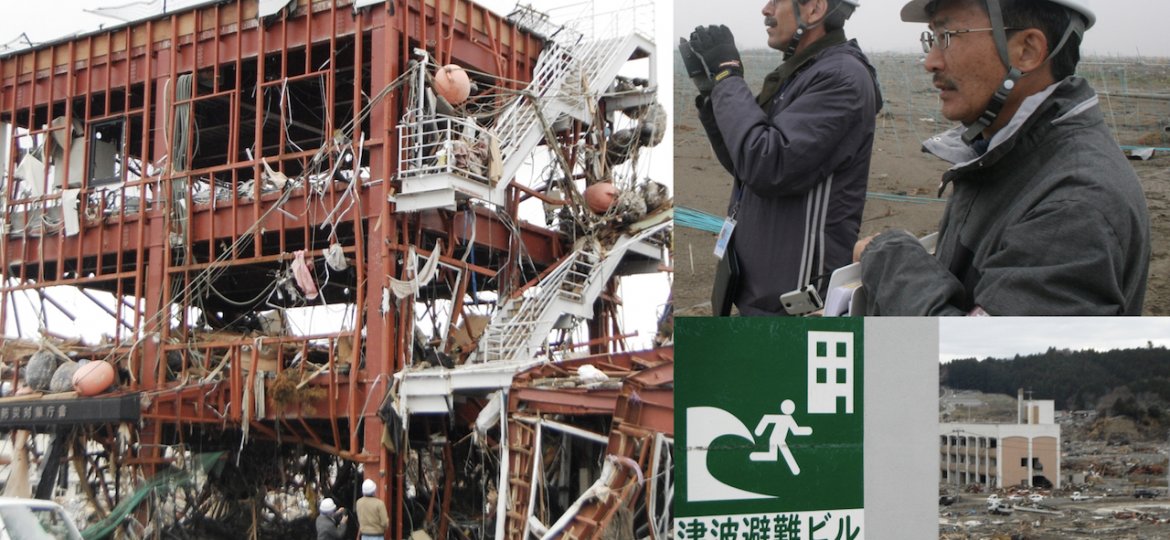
[674, 317, 861, 540]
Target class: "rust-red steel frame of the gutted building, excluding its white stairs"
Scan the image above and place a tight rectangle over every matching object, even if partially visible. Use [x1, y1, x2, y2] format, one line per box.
[0, 0, 678, 538]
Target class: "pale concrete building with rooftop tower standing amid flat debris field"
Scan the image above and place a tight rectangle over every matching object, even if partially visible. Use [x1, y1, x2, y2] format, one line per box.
[938, 393, 1061, 489]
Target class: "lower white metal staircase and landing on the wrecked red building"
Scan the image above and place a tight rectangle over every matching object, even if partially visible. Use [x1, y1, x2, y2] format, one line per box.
[395, 222, 670, 415]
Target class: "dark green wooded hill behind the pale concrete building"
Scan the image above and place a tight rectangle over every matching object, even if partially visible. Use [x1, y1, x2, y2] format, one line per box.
[940, 344, 1170, 421]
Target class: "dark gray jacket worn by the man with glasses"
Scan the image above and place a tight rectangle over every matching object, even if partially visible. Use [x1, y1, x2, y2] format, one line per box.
[861, 77, 1150, 316]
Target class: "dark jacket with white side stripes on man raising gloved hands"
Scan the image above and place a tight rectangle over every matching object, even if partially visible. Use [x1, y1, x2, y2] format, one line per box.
[698, 35, 881, 316]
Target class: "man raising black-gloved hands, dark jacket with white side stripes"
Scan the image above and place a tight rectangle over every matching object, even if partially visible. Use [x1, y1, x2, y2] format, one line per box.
[679, 0, 881, 316]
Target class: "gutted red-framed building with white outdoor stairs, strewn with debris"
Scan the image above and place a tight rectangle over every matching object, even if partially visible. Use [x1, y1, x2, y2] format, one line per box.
[0, 0, 673, 539]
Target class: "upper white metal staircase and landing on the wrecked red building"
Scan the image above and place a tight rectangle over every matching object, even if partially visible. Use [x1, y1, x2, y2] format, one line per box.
[392, 8, 654, 212]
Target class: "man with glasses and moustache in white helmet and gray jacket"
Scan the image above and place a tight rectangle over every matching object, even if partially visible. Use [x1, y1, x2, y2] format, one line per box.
[855, 0, 1150, 316]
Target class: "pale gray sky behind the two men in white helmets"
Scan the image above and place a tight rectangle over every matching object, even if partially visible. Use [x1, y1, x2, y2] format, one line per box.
[674, 0, 1170, 57]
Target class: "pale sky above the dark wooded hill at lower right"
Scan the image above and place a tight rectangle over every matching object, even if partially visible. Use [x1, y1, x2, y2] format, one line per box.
[938, 317, 1170, 362]
